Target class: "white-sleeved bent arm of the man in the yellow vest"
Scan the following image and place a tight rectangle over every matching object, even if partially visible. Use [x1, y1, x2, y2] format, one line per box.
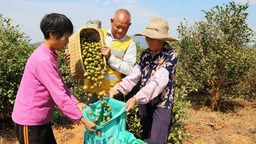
[108, 42, 137, 75]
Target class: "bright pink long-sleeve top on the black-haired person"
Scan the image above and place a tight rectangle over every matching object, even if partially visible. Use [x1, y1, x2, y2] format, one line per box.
[12, 44, 82, 126]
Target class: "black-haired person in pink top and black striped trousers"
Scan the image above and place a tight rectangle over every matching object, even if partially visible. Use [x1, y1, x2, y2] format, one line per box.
[12, 13, 96, 144]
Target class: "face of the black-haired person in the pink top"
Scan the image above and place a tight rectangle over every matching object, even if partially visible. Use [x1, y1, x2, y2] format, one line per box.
[51, 33, 71, 51]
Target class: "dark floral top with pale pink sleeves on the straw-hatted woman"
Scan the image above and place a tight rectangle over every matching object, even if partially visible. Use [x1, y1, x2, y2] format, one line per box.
[113, 43, 178, 109]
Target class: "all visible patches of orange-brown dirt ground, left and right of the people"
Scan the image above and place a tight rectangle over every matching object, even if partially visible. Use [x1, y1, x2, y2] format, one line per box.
[0, 99, 256, 144]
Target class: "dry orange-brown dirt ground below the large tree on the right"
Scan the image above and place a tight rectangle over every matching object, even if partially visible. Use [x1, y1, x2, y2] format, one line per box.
[184, 99, 256, 144]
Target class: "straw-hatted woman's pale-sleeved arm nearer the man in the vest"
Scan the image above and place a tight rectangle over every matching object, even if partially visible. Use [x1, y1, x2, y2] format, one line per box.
[107, 65, 141, 97]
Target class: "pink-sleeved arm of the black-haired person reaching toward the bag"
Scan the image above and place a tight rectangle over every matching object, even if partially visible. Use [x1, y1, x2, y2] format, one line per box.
[36, 60, 82, 121]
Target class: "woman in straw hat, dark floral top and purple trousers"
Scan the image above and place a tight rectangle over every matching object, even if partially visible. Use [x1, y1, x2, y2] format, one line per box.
[108, 18, 177, 144]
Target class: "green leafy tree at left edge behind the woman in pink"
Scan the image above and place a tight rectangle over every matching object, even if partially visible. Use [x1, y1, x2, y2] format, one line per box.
[0, 14, 34, 115]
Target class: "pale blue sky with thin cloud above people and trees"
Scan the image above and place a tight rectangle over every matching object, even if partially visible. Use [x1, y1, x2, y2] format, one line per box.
[0, 0, 256, 43]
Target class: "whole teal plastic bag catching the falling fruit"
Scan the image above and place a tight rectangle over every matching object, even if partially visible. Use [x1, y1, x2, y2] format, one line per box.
[83, 98, 146, 144]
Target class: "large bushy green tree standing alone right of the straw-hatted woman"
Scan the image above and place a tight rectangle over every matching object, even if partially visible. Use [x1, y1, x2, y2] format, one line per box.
[178, 2, 253, 110]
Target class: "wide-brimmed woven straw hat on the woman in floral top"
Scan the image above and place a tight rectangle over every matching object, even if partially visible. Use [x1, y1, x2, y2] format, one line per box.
[135, 18, 178, 42]
